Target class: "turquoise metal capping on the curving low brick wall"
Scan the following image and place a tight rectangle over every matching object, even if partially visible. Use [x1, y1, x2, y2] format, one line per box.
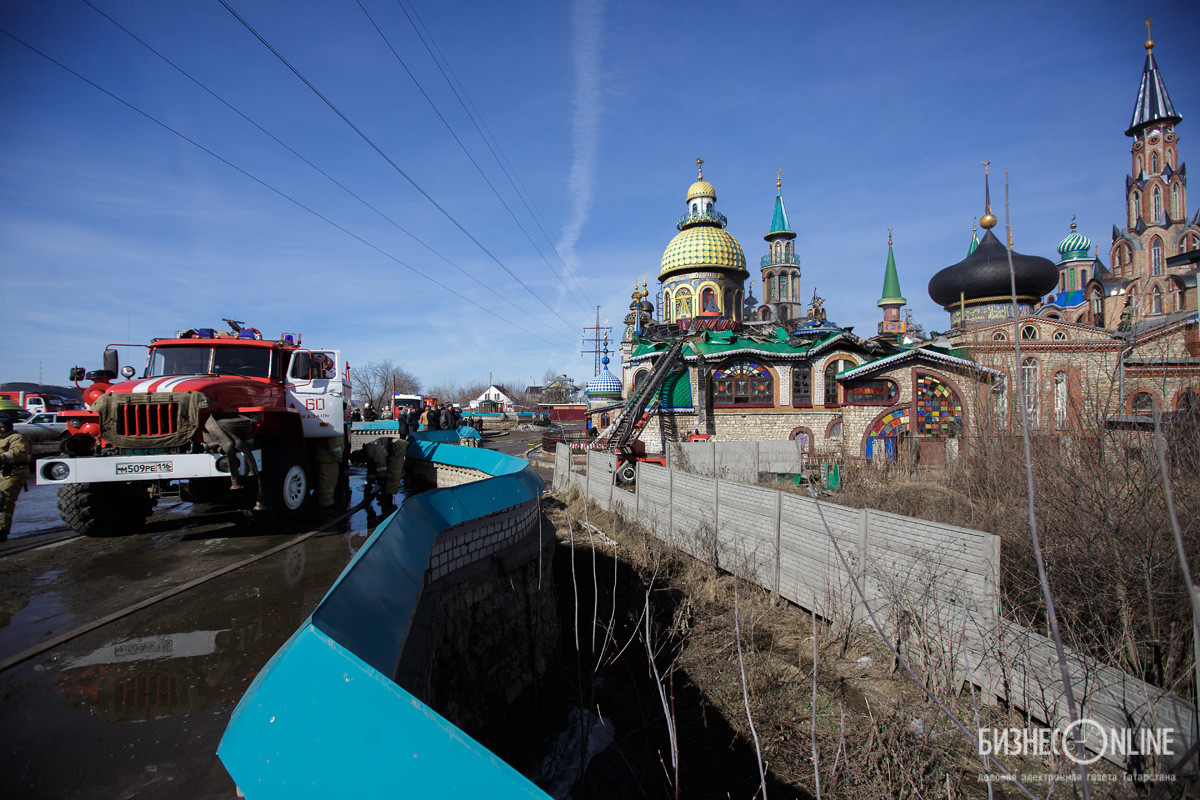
[217, 441, 547, 800]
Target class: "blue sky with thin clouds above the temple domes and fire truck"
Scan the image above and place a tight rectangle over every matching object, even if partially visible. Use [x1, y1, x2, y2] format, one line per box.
[0, 0, 1200, 393]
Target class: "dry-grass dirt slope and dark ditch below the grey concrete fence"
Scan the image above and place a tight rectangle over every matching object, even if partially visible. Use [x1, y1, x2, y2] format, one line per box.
[544, 497, 1134, 799]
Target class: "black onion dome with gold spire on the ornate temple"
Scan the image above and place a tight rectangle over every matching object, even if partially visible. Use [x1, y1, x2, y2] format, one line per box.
[929, 230, 1058, 308]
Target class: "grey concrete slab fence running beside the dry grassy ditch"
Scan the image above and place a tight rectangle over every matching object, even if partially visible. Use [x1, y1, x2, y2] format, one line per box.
[553, 441, 1196, 765]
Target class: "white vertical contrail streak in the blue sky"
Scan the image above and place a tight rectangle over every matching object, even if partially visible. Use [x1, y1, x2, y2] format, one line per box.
[558, 0, 604, 270]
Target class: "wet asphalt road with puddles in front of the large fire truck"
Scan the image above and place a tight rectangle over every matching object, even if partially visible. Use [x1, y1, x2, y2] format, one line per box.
[0, 432, 548, 800]
